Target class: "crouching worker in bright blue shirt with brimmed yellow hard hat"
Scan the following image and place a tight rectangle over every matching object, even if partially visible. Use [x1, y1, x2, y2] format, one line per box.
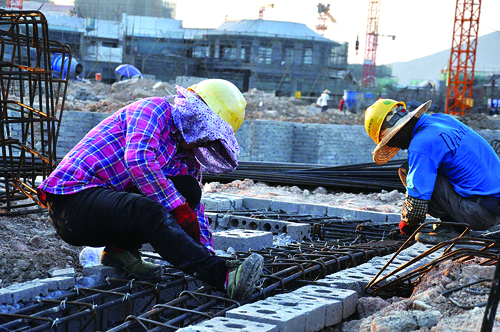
[365, 99, 500, 244]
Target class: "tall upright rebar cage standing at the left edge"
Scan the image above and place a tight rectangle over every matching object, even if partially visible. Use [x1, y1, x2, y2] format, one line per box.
[0, 11, 71, 215]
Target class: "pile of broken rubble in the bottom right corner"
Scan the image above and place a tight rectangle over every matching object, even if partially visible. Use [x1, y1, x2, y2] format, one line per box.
[341, 258, 500, 332]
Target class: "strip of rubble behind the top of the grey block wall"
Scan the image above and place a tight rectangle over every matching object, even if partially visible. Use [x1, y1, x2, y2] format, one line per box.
[65, 78, 500, 130]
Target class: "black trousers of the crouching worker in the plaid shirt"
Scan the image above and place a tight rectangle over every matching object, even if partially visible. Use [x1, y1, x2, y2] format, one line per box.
[47, 176, 227, 290]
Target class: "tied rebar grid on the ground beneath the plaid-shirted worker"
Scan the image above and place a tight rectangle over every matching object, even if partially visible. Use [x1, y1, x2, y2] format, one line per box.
[0, 241, 402, 331]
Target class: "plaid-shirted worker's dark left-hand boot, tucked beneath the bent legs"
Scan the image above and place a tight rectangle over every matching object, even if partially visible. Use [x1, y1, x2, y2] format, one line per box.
[101, 246, 163, 279]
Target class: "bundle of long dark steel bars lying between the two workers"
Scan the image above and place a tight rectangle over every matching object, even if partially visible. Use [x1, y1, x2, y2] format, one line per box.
[203, 160, 405, 192]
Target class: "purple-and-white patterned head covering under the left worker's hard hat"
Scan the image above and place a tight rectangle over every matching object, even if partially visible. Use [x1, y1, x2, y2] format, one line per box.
[172, 86, 240, 174]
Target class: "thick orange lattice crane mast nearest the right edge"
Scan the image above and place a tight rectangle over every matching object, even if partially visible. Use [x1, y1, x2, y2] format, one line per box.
[445, 0, 481, 115]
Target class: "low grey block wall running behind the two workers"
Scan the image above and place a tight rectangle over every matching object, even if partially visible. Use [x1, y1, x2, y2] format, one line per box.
[53, 111, 500, 166]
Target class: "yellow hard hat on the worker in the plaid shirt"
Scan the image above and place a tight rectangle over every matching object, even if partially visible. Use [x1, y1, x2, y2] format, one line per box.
[188, 79, 247, 132]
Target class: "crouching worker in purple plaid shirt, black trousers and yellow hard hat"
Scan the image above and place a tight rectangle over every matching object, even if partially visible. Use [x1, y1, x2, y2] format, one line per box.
[38, 79, 263, 300]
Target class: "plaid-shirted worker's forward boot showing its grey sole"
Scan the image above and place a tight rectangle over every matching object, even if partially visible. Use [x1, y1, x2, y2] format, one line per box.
[226, 254, 264, 301]
